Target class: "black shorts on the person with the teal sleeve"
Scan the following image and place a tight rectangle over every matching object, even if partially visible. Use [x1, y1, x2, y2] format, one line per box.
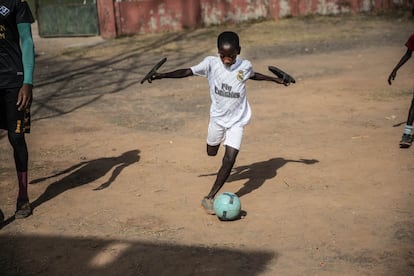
[0, 88, 30, 133]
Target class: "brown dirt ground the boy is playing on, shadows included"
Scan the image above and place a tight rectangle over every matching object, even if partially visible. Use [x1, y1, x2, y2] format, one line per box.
[0, 13, 414, 276]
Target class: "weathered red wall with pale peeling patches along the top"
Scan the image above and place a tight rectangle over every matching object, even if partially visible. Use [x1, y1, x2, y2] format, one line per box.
[97, 0, 412, 38]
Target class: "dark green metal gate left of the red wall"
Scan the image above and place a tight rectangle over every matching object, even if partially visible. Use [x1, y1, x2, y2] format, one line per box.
[36, 0, 99, 37]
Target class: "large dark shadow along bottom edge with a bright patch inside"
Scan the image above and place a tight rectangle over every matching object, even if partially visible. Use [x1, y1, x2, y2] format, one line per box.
[0, 236, 277, 276]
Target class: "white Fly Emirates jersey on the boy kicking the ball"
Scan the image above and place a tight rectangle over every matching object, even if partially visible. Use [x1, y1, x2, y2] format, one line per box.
[191, 56, 253, 128]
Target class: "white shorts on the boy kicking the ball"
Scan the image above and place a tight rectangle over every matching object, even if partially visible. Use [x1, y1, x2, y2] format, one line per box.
[207, 120, 244, 150]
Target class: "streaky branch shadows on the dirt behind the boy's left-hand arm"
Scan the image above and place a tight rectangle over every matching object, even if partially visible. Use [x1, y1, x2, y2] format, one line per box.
[32, 30, 215, 121]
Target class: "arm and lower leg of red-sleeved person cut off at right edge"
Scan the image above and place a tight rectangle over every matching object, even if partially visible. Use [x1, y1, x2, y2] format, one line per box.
[388, 33, 414, 148]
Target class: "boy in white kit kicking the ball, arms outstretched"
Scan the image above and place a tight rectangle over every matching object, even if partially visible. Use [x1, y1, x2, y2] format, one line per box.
[149, 32, 289, 214]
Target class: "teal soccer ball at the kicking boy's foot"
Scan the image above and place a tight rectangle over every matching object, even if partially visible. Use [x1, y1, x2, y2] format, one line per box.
[213, 192, 241, 220]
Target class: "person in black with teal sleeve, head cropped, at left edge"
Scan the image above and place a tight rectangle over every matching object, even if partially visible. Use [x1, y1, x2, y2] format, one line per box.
[0, 0, 34, 218]
